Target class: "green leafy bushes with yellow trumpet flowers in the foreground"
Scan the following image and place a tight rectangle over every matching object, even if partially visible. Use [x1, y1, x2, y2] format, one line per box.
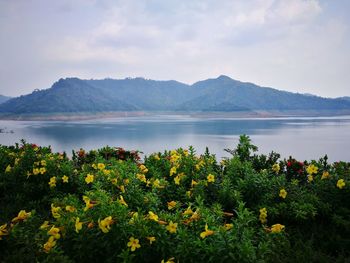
[0, 135, 350, 262]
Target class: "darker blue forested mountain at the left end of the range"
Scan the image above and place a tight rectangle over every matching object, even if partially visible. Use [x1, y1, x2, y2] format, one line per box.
[0, 78, 136, 114]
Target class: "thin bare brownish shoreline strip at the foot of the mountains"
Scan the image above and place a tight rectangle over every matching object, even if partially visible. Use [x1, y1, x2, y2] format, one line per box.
[0, 110, 350, 121]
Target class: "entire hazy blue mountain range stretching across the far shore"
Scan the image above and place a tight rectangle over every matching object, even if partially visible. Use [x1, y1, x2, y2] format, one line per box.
[0, 76, 350, 115]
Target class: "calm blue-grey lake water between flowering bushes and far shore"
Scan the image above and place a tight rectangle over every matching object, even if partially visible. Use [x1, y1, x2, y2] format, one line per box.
[0, 116, 350, 161]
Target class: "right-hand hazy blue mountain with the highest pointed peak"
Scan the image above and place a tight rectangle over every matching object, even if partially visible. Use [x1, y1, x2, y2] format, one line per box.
[180, 76, 350, 111]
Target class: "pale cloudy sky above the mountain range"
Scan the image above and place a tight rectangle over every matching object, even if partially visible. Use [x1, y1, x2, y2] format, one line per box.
[0, 0, 350, 97]
